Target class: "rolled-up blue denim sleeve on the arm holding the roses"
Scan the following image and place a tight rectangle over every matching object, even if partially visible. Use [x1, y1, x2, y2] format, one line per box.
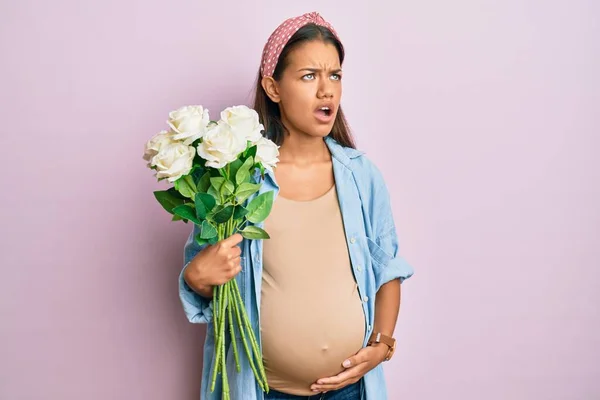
[179, 225, 213, 324]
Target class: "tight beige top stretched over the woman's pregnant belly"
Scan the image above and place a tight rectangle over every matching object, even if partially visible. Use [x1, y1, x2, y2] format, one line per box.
[261, 185, 365, 395]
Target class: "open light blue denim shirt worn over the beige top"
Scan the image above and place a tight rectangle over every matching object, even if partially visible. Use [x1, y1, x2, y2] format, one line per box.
[179, 136, 414, 400]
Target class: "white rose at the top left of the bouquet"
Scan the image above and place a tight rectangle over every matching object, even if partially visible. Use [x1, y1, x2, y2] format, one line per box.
[167, 106, 210, 145]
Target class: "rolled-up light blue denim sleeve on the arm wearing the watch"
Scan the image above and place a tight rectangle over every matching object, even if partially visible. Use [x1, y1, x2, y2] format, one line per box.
[368, 166, 414, 290]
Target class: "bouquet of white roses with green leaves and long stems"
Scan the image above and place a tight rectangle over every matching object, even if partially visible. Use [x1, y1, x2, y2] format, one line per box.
[143, 105, 279, 399]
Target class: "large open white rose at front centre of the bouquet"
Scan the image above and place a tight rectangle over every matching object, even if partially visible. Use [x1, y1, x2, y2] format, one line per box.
[198, 121, 246, 168]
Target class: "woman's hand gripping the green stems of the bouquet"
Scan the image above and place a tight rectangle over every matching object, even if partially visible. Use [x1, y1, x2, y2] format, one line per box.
[183, 233, 243, 298]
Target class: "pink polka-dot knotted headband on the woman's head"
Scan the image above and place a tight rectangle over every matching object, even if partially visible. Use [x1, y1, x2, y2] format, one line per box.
[260, 12, 340, 77]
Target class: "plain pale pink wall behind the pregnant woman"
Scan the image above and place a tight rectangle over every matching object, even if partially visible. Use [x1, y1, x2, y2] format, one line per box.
[0, 0, 600, 400]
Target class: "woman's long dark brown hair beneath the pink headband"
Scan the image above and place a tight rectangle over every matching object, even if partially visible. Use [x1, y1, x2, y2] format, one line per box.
[254, 24, 356, 149]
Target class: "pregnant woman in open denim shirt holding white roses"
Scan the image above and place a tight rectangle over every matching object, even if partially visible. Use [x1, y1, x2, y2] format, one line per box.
[180, 13, 413, 400]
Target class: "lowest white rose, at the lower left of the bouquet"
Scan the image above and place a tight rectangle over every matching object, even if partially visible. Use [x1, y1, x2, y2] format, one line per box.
[152, 142, 196, 182]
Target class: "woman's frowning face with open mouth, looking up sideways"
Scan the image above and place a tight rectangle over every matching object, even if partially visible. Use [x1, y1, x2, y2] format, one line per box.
[267, 40, 342, 137]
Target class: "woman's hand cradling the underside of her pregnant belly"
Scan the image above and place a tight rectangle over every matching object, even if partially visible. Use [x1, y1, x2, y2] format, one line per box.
[310, 343, 388, 393]
